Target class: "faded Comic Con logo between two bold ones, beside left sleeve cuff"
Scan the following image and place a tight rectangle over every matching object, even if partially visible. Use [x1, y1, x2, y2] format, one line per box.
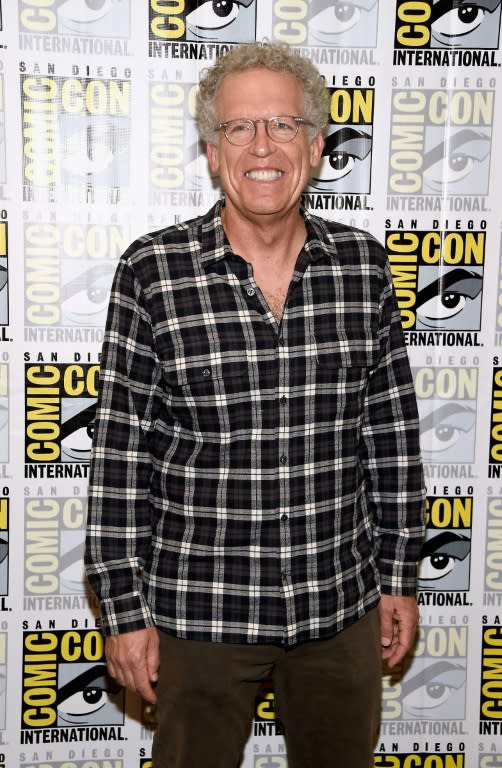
[24, 496, 87, 596]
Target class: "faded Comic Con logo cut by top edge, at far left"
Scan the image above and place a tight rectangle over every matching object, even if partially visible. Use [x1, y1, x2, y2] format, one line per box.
[19, 0, 131, 37]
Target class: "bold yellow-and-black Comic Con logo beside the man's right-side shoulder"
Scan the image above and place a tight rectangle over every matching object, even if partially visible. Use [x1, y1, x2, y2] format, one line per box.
[386, 222, 486, 331]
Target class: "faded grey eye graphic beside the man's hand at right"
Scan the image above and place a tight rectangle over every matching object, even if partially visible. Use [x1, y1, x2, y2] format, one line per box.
[402, 661, 465, 717]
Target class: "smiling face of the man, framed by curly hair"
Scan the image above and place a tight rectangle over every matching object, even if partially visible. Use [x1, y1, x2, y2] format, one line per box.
[207, 68, 323, 221]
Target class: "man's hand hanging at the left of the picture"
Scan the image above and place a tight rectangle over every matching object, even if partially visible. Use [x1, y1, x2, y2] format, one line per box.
[105, 627, 160, 704]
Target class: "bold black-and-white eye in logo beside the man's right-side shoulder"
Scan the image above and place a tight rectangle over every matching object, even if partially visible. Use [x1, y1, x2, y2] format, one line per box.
[417, 267, 483, 328]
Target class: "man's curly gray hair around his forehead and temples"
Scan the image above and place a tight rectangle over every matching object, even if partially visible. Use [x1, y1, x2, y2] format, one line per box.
[196, 40, 329, 143]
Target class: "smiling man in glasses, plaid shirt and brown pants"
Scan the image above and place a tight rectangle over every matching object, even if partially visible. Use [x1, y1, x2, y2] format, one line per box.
[86, 43, 424, 768]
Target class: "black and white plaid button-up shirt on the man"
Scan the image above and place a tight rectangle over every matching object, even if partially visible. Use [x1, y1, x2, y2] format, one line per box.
[86, 202, 424, 646]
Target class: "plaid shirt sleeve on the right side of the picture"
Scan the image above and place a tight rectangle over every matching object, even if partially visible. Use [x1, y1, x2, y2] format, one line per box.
[360, 250, 425, 595]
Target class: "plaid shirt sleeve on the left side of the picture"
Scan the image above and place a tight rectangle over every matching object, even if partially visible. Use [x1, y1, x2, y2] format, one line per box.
[85, 250, 160, 634]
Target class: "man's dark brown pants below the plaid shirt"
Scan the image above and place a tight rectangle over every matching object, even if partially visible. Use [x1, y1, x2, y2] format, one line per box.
[153, 609, 381, 768]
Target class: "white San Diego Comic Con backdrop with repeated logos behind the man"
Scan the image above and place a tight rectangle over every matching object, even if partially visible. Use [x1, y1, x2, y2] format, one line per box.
[0, 0, 502, 768]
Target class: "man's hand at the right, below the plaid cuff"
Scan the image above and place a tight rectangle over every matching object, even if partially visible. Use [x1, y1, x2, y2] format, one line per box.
[380, 595, 419, 667]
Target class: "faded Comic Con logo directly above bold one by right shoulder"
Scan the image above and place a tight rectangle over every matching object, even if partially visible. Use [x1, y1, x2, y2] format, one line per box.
[388, 89, 495, 195]
